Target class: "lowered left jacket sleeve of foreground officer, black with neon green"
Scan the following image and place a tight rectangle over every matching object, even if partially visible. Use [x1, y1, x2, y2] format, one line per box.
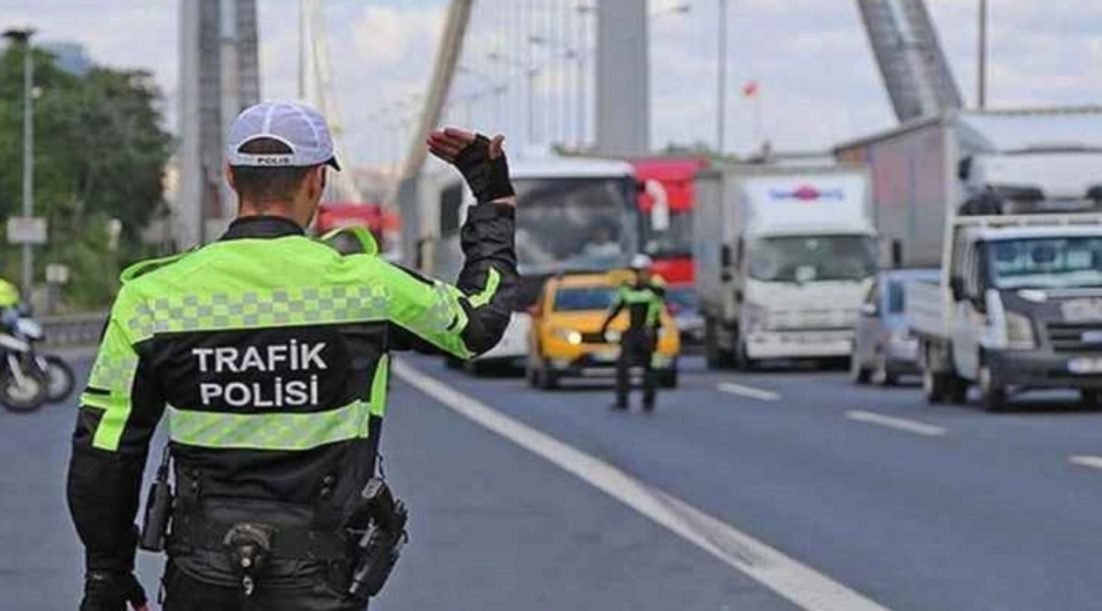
[67, 311, 164, 570]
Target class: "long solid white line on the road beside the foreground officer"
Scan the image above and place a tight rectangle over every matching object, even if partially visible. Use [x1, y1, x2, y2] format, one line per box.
[393, 362, 890, 611]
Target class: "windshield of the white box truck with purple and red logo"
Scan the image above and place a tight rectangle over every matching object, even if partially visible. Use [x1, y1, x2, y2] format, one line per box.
[749, 235, 876, 282]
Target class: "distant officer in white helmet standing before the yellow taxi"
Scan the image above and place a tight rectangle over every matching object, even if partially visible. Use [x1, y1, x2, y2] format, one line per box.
[601, 255, 666, 411]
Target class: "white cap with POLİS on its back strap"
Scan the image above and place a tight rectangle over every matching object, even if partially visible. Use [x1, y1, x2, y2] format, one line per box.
[226, 101, 341, 170]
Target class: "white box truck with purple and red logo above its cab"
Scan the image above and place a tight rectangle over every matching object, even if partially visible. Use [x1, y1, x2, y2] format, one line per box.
[693, 164, 878, 368]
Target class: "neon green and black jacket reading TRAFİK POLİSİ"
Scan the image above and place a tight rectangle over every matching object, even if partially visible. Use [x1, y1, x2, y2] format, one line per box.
[68, 204, 517, 570]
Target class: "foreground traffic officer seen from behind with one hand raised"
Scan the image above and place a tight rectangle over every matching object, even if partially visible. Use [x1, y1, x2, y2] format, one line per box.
[68, 103, 517, 611]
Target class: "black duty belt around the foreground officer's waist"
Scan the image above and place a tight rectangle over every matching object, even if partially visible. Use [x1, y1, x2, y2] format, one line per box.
[169, 519, 352, 560]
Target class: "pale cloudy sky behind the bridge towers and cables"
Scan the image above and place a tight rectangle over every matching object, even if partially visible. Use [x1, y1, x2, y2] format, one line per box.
[0, 0, 1102, 163]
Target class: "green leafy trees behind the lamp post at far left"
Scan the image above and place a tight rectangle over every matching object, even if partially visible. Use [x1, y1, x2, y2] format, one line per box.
[0, 45, 172, 307]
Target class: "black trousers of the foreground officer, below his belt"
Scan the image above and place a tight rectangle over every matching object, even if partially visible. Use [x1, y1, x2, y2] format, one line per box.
[162, 561, 367, 611]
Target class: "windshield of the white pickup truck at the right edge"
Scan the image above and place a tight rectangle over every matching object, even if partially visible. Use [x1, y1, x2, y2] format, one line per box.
[987, 236, 1102, 289]
